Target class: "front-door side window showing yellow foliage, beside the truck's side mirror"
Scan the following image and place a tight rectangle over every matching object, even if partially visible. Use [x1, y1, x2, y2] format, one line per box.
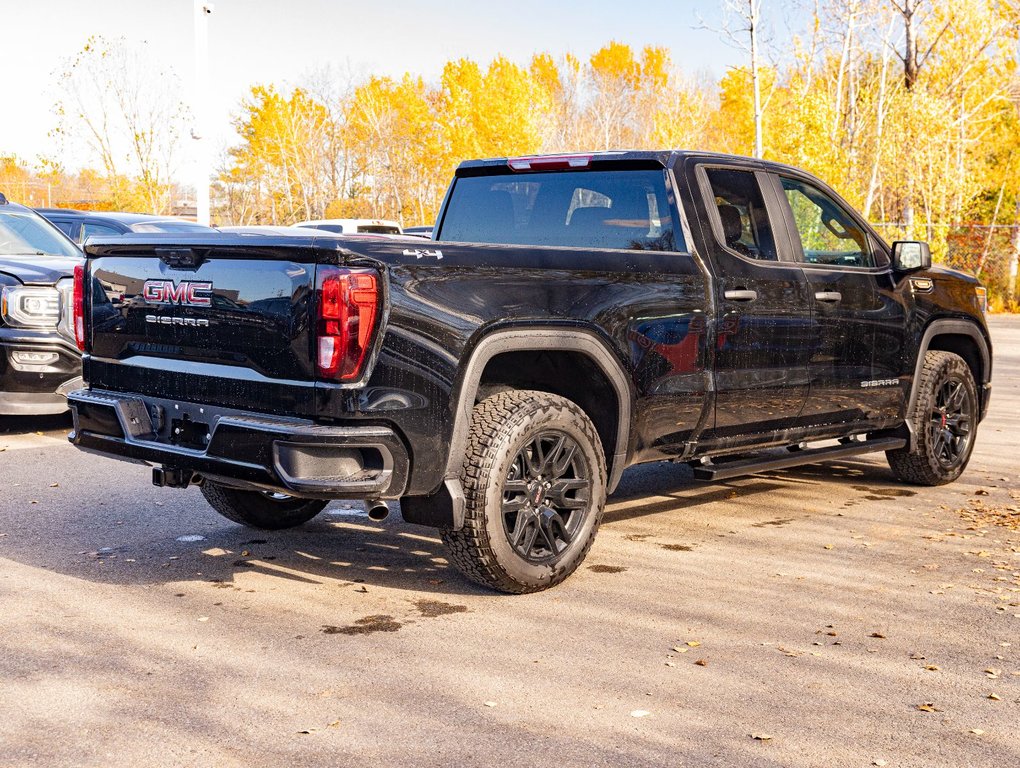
[780, 177, 876, 267]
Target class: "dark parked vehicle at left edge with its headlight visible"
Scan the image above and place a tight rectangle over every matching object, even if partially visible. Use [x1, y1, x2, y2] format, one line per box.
[0, 195, 82, 416]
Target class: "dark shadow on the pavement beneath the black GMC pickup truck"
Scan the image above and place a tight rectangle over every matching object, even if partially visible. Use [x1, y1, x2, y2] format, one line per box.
[15, 452, 912, 595]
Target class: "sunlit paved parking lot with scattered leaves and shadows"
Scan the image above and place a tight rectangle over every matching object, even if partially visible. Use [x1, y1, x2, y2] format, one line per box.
[0, 318, 1020, 768]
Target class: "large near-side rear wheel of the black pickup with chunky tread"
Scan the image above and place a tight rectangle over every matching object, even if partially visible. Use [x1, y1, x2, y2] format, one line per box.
[441, 390, 607, 594]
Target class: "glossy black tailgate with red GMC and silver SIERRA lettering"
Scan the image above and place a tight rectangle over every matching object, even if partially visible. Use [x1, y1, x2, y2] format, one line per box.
[86, 236, 339, 416]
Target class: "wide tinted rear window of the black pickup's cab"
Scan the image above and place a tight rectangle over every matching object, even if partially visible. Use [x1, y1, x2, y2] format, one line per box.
[438, 170, 686, 251]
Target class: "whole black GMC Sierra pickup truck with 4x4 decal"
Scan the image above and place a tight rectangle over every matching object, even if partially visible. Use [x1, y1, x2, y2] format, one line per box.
[63, 151, 991, 593]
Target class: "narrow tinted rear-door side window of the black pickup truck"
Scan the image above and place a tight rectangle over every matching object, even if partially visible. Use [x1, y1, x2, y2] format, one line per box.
[705, 168, 778, 261]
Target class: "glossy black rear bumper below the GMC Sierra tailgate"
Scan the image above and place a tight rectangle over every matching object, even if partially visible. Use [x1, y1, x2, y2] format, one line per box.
[67, 390, 409, 499]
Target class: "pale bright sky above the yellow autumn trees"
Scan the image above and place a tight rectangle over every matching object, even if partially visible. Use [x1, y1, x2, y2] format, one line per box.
[0, 0, 793, 173]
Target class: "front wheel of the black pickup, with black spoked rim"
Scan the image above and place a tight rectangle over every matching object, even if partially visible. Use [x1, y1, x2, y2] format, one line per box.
[885, 351, 978, 485]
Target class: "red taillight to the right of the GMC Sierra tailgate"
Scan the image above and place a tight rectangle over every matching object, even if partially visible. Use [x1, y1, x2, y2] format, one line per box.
[315, 266, 379, 381]
